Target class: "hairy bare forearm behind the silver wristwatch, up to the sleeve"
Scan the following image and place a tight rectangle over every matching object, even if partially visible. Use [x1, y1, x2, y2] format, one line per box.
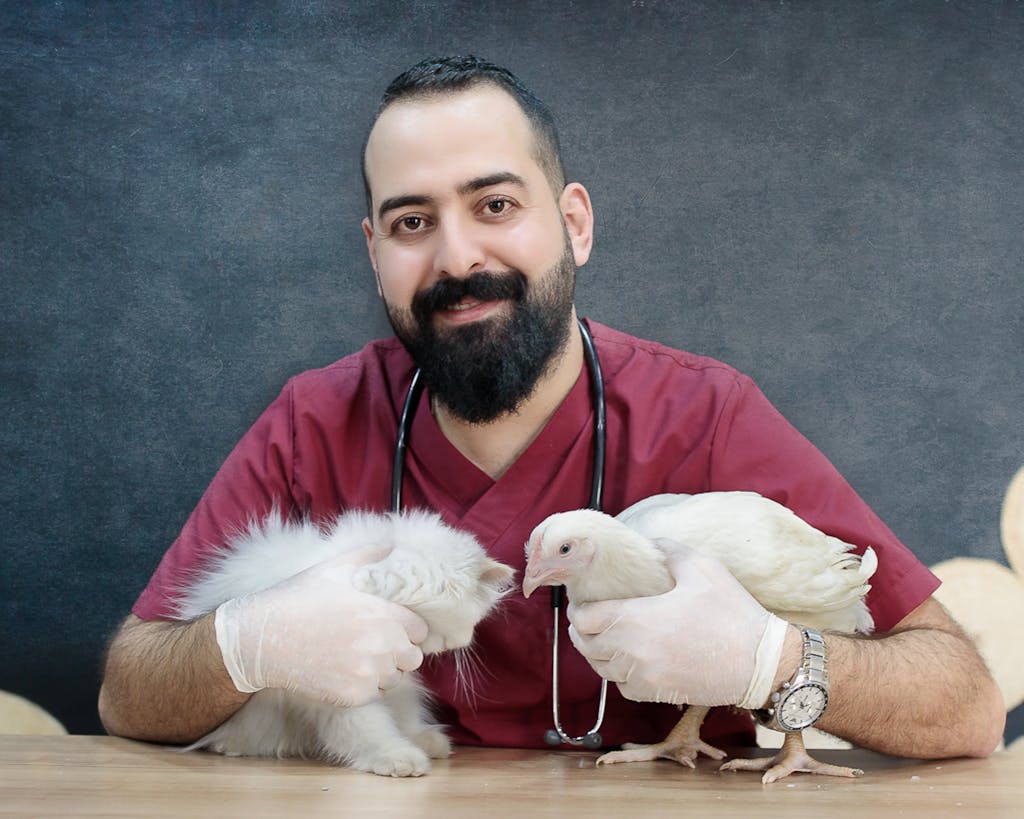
[794, 601, 1006, 759]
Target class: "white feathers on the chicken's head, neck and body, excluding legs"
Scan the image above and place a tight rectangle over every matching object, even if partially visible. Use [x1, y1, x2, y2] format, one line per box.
[539, 491, 878, 634]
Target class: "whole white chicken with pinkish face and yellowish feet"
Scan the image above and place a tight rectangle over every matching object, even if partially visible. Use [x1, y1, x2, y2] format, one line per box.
[523, 491, 878, 783]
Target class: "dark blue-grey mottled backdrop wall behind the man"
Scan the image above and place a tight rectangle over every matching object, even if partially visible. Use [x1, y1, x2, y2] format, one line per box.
[0, 0, 1024, 733]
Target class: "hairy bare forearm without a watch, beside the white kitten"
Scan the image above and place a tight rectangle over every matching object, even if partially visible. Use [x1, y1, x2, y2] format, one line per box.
[99, 615, 249, 743]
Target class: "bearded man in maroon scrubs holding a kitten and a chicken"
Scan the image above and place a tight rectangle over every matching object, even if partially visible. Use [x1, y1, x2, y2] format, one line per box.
[99, 57, 1005, 758]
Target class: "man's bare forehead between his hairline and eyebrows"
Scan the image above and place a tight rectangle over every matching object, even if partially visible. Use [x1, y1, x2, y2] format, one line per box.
[366, 85, 544, 203]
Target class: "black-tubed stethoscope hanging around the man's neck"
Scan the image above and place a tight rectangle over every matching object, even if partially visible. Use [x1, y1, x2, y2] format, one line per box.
[391, 318, 608, 748]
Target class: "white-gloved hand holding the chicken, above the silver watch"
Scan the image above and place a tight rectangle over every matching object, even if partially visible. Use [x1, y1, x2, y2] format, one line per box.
[566, 541, 790, 708]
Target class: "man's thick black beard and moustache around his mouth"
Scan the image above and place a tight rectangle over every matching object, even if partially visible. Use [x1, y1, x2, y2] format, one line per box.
[384, 241, 575, 424]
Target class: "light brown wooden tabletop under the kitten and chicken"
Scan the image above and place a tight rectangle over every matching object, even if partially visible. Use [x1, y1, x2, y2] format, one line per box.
[0, 736, 1024, 819]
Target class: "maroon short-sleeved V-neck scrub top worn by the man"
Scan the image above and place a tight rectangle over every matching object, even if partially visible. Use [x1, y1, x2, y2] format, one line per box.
[133, 321, 939, 747]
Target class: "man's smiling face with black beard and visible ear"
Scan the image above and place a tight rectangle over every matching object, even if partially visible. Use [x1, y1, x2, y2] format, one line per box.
[364, 85, 591, 423]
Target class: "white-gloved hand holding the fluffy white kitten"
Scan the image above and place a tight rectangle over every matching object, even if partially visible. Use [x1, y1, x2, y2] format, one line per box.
[214, 547, 427, 705]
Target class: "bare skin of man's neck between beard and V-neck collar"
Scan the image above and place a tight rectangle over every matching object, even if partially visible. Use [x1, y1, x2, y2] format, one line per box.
[431, 310, 584, 480]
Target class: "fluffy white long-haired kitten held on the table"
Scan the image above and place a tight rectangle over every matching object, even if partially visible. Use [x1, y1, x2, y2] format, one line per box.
[177, 511, 513, 776]
